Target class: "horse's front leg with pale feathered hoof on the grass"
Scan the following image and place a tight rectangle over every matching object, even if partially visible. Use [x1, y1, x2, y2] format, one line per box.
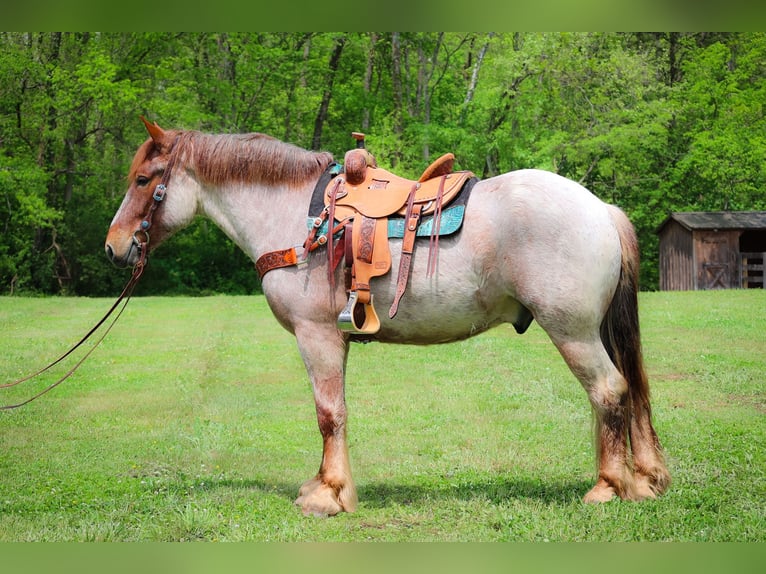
[295, 325, 357, 516]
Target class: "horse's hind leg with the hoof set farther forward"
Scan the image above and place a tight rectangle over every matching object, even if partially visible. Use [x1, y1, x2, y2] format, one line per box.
[552, 335, 644, 502]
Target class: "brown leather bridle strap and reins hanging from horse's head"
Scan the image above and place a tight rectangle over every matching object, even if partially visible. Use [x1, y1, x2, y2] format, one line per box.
[0, 139, 178, 410]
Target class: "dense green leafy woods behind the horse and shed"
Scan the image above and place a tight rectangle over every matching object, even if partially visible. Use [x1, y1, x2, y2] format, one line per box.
[0, 32, 766, 295]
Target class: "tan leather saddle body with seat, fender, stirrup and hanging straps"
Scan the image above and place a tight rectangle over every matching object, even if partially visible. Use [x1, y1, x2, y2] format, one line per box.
[324, 149, 473, 334]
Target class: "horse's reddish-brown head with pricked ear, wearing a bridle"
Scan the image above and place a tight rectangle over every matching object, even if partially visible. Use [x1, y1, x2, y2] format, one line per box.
[105, 117, 194, 267]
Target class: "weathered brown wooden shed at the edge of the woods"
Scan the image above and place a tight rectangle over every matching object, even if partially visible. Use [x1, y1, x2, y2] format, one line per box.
[657, 211, 766, 291]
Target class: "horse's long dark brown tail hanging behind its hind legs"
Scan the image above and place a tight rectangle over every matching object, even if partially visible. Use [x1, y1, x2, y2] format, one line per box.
[601, 205, 652, 432]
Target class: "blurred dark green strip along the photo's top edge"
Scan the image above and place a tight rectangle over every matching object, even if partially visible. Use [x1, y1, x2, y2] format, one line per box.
[0, 0, 766, 32]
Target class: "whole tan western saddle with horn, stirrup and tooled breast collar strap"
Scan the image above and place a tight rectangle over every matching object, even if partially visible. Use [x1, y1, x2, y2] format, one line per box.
[256, 132, 473, 334]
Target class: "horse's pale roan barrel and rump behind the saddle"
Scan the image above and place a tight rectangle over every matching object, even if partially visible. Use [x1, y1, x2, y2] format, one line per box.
[373, 170, 632, 342]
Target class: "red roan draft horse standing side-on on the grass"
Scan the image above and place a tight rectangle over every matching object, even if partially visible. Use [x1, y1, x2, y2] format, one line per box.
[105, 118, 670, 516]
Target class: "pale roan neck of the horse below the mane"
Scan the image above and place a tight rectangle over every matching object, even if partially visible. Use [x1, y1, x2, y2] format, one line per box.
[200, 183, 313, 261]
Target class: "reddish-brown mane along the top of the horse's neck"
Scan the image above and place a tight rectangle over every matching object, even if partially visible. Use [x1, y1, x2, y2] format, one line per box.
[178, 131, 332, 185]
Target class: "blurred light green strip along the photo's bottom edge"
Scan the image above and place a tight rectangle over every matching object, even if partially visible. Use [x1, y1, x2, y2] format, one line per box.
[1, 543, 764, 574]
